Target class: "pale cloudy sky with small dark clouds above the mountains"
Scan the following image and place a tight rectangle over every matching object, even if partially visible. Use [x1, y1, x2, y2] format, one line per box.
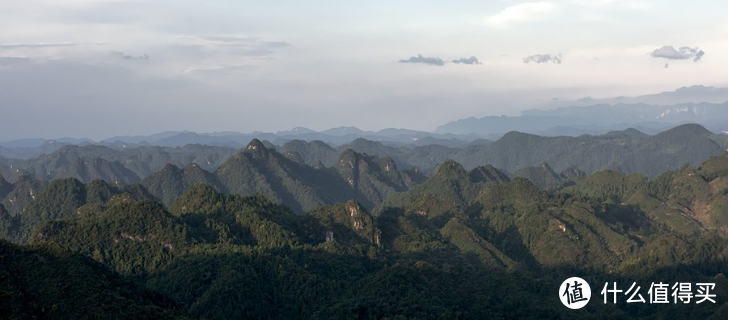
[0, 0, 729, 141]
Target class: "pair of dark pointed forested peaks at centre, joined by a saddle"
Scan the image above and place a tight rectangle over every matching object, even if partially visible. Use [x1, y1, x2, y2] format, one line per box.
[206, 140, 422, 213]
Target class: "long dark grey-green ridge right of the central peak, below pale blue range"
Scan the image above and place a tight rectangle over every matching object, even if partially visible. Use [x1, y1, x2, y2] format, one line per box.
[283, 124, 727, 177]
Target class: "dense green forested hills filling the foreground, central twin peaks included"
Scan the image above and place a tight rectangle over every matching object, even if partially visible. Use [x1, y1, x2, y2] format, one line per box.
[0, 140, 727, 319]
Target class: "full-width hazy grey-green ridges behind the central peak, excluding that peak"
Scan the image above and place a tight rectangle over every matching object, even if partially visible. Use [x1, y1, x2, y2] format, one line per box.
[0, 124, 727, 190]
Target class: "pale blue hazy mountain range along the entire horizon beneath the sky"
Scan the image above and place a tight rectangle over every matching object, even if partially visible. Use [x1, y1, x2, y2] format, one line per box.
[0, 86, 729, 159]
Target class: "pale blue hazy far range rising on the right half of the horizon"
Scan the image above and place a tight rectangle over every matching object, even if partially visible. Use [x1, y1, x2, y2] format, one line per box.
[435, 86, 729, 136]
